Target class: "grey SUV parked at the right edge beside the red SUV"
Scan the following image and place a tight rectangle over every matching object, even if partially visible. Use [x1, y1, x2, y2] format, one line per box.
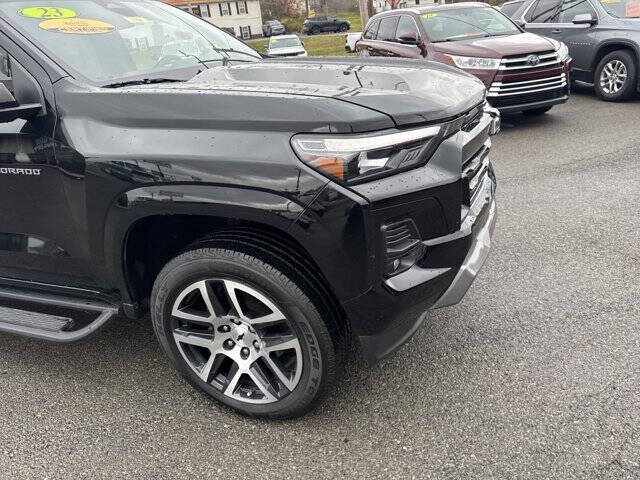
[501, 0, 640, 101]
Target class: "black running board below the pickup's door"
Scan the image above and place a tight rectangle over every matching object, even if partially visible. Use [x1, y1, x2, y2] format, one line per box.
[0, 288, 118, 343]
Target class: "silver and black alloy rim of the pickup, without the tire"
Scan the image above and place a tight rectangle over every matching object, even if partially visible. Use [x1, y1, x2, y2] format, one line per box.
[171, 279, 303, 404]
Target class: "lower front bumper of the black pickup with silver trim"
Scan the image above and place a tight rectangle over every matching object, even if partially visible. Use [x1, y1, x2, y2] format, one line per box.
[343, 169, 497, 365]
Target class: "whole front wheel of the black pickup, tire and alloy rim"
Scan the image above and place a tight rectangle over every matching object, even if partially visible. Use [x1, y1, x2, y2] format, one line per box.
[151, 243, 345, 418]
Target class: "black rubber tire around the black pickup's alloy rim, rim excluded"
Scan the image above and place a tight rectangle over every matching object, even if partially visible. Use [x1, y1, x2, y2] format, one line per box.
[152, 250, 335, 417]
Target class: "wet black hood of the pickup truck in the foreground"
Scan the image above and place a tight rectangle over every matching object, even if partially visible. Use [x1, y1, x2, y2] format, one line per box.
[172, 57, 485, 126]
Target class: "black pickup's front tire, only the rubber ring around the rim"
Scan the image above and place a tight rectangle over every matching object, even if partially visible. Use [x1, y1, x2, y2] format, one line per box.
[151, 242, 348, 419]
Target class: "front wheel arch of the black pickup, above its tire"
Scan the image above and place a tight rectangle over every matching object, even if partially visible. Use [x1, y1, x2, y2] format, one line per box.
[105, 185, 348, 317]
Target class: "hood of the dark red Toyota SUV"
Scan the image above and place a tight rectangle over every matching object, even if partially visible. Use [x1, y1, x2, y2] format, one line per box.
[433, 32, 555, 58]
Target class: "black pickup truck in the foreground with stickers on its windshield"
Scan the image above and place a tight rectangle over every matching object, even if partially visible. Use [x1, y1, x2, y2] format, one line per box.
[0, 0, 499, 418]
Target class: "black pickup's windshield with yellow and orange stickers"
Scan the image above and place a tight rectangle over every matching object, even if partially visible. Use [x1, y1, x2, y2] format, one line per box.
[0, 0, 260, 84]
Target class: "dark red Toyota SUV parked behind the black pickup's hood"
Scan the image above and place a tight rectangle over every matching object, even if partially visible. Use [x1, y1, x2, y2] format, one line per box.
[356, 3, 571, 115]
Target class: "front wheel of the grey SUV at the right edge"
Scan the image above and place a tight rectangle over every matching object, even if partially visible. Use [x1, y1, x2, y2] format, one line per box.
[594, 50, 637, 102]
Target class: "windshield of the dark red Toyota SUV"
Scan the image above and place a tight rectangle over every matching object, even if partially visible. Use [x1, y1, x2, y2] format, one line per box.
[420, 7, 520, 42]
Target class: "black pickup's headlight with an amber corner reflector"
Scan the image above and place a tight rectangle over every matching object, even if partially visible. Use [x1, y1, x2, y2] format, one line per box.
[291, 126, 440, 183]
